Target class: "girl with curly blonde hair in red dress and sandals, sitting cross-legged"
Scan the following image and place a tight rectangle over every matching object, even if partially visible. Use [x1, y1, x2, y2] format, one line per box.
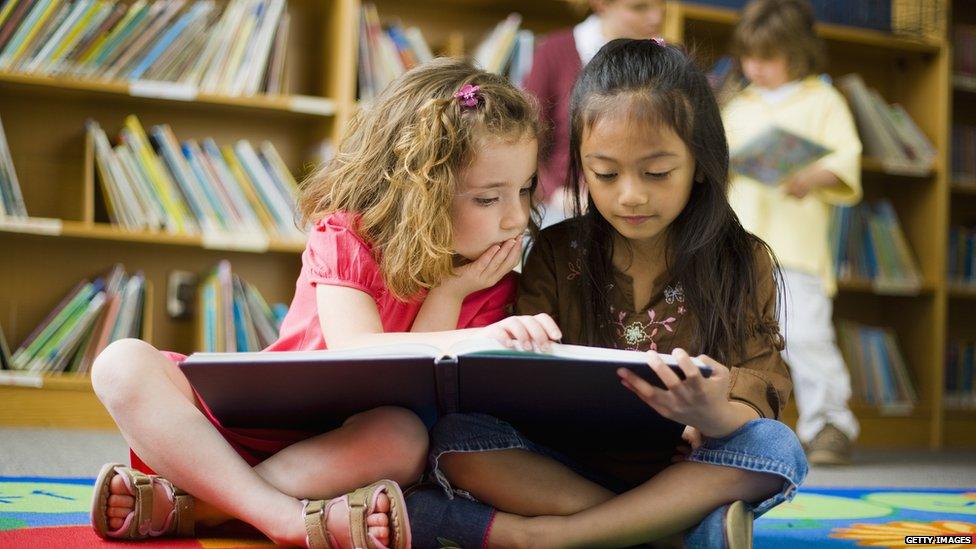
[92, 60, 560, 548]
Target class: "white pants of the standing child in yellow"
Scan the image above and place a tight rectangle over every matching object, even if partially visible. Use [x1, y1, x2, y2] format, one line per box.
[779, 269, 860, 443]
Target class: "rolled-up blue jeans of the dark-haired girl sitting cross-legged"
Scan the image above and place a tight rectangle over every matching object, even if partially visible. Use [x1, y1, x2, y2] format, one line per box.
[407, 414, 808, 548]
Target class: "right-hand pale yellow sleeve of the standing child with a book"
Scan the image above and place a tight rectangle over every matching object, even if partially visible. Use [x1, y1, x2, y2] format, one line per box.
[817, 88, 862, 206]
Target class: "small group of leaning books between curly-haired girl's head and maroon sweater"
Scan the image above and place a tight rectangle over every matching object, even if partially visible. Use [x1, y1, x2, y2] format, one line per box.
[474, 13, 535, 86]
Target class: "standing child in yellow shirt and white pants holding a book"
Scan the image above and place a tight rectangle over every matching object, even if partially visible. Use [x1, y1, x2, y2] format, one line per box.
[722, 0, 861, 464]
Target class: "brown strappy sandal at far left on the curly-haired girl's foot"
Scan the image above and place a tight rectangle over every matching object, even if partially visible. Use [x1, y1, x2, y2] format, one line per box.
[91, 463, 194, 540]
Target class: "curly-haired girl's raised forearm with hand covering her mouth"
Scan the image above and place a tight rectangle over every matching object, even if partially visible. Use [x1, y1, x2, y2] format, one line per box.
[410, 236, 522, 332]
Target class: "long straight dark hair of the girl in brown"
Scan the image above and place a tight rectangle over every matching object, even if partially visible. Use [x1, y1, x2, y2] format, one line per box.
[569, 39, 775, 361]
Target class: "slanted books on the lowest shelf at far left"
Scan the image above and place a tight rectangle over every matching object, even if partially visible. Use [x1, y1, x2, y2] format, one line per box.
[7, 265, 147, 373]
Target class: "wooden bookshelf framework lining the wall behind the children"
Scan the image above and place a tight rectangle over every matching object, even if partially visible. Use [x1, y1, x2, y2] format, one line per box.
[0, 0, 964, 447]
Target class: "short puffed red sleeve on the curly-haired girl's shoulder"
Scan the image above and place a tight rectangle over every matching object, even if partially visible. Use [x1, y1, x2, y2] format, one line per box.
[302, 215, 382, 299]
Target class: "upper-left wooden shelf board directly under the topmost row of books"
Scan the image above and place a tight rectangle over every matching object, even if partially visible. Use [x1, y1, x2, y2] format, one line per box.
[0, 72, 337, 117]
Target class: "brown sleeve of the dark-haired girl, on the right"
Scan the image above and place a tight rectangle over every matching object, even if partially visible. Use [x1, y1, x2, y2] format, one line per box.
[729, 248, 793, 419]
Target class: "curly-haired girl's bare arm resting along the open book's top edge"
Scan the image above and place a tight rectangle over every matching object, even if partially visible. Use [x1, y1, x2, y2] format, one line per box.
[315, 284, 562, 349]
